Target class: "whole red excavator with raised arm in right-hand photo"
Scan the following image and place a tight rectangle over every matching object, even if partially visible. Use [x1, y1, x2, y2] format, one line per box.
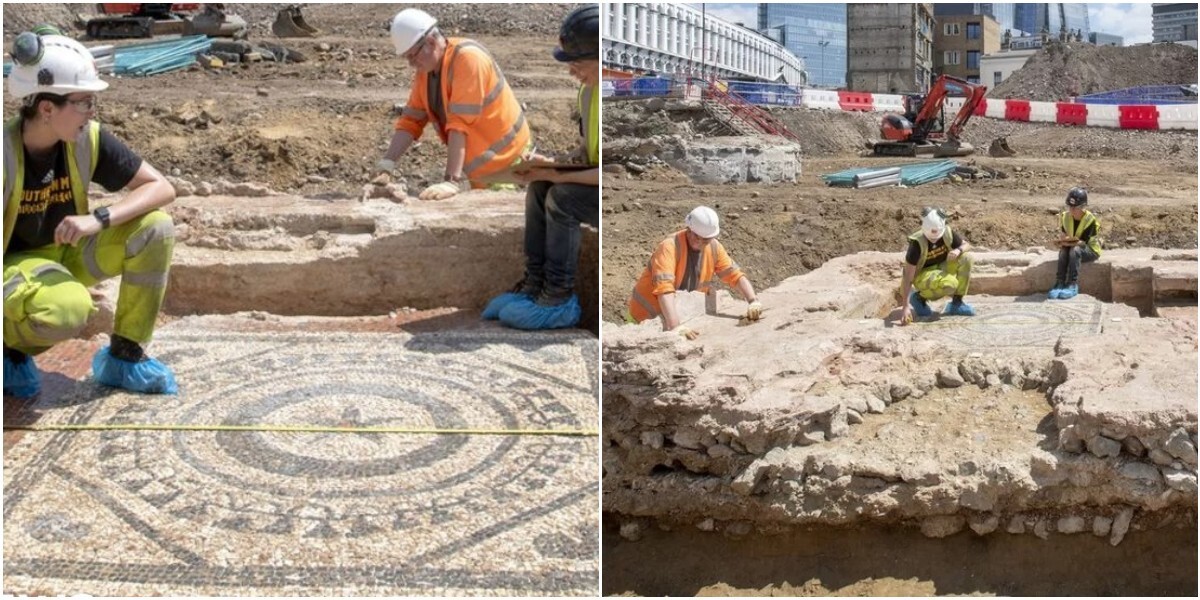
[875, 74, 988, 157]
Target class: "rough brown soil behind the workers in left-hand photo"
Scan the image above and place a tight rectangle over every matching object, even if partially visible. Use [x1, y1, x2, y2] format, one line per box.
[4, 4, 578, 198]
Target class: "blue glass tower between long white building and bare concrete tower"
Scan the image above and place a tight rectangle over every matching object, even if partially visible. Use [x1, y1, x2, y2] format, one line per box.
[758, 4, 846, 88]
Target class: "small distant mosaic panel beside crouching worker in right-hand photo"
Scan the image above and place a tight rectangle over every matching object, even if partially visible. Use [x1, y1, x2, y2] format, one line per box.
[920, 296, 1104, 349]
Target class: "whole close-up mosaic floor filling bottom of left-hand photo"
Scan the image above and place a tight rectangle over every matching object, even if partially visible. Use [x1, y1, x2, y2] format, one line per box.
[4, 326, 599, 595]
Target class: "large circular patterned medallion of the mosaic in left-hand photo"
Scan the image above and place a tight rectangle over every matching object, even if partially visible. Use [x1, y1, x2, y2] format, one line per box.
[90, 340, 594, 536]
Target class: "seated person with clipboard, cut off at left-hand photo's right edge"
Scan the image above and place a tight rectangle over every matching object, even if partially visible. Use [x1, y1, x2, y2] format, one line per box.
[484, 5, 600, 330]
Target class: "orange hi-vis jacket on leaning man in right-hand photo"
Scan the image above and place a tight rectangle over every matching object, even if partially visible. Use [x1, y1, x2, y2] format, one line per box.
[629, 229, 742, 323]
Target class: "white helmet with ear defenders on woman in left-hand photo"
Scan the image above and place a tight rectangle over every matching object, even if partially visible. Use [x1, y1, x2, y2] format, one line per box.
[7, 28, 108, 98]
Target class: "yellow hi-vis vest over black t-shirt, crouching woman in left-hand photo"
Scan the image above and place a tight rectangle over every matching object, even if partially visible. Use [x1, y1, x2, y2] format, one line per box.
[4, 116, 100, 251]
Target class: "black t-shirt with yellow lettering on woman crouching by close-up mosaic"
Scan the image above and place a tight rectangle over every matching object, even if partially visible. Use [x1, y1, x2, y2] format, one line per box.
[5, 128, 142, 252]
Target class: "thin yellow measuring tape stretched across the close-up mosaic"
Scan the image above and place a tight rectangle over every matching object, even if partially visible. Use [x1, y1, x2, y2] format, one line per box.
[4, 424, 600, 437]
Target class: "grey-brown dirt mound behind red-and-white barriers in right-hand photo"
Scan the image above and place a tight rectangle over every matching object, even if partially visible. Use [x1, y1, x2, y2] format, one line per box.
[988, 41, 1196, 102]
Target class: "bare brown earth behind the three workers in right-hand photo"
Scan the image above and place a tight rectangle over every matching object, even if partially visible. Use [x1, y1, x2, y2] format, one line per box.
[604, 101, 1196, 322]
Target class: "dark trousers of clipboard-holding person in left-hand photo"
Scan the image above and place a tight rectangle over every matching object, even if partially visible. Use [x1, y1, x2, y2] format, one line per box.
[526, 181, 600, 299]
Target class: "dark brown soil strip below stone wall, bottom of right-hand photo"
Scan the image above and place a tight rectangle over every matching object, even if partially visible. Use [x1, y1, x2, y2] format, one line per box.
[601, 524, 1196, 596]
